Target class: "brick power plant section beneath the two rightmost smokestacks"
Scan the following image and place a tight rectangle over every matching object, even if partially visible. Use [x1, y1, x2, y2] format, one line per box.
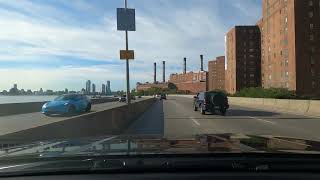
[169, 71, 208, 94]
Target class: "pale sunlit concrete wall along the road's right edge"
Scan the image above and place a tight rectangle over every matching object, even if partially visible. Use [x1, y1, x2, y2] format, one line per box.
[171, 95, 320, 117]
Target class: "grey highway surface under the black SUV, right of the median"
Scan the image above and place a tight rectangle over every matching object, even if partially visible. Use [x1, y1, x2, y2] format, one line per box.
[126, 97, 320, 140]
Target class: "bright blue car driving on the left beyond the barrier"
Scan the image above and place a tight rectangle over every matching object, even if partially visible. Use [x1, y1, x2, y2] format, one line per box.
[41, 94, 91, 115]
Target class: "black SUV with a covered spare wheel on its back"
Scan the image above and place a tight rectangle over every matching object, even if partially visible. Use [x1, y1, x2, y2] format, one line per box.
[193, 91, 229, 115]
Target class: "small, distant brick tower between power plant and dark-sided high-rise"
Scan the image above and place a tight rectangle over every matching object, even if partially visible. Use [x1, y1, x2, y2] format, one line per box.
[208, 56, 225, 90]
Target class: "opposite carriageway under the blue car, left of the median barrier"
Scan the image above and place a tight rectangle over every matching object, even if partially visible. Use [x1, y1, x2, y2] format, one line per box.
[0, 98, 144, 136]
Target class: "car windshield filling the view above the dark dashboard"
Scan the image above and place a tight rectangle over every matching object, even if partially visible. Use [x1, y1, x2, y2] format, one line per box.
[0, 0, 320, 176]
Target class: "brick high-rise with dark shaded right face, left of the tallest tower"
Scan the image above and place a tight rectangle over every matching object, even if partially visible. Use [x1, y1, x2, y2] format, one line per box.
[225, 26, 261, 94]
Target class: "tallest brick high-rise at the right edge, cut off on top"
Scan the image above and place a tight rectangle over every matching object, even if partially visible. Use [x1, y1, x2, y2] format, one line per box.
[258, 0, 320, 95]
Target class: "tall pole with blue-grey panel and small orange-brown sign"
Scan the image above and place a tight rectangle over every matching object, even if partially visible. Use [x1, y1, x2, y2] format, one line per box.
[117, 0, 136, 104]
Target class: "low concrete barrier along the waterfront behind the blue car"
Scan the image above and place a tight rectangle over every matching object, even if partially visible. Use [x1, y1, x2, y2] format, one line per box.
[0, 98, 118, 116]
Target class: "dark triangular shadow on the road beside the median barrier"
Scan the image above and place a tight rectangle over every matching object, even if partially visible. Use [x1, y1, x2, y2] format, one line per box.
[125, 100, 164, 137]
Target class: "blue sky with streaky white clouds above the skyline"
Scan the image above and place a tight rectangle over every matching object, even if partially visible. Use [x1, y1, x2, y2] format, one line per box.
[0, 0, 261, 91]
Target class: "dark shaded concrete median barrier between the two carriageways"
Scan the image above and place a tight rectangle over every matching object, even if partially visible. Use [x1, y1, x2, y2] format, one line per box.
[0, 98, 156, 142]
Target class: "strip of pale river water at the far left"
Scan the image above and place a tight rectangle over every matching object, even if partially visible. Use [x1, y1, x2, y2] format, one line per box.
[0, 96, 57, 104]
